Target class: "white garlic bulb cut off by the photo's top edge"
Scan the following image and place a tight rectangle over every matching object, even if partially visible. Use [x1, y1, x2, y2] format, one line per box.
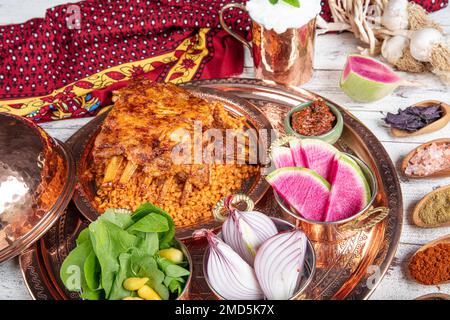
[381, 0, 409, 31]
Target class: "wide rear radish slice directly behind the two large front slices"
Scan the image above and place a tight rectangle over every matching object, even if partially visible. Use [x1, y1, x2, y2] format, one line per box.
[301, 139, 340, 181]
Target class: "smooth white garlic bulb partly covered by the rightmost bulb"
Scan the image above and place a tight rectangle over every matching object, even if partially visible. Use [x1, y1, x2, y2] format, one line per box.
[410, 28, 444, 62]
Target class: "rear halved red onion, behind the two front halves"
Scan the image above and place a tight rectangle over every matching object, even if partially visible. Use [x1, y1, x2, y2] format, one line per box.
[222, 200, 278, 266]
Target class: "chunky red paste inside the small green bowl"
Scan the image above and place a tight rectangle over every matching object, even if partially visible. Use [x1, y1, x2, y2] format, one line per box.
[291, 99, 336, 136]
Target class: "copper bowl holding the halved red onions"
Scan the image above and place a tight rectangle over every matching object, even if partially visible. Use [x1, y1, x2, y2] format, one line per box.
[203, 217, 316, 300]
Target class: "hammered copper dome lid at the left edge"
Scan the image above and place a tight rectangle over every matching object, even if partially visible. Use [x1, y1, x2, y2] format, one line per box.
[0, 113, 75, 262]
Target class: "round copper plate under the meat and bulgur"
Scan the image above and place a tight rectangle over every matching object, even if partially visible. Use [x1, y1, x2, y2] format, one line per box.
[68, 87, 272, 239]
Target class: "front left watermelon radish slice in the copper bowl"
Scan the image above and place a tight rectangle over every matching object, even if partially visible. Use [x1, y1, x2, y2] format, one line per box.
[266, 168, 330, 221]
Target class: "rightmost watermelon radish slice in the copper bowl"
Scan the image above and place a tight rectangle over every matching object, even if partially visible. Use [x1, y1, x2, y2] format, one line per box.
[325, 154, 371, 221]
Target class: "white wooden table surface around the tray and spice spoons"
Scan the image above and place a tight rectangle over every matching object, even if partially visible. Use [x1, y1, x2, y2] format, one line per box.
[0, 0, 450, 299]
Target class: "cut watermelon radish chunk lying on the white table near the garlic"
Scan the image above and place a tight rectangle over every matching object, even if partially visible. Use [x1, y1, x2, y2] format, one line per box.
[340, 54, 405, 102]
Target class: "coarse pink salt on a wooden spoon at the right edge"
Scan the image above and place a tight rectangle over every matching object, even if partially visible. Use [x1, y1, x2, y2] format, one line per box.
[405, 143, 450, 176]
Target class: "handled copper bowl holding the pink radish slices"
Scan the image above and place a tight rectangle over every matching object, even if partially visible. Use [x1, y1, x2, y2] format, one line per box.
[273, 154, 389, 243]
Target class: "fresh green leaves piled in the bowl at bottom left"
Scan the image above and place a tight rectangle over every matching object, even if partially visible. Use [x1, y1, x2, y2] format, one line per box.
[60, 203, 189, 300]
